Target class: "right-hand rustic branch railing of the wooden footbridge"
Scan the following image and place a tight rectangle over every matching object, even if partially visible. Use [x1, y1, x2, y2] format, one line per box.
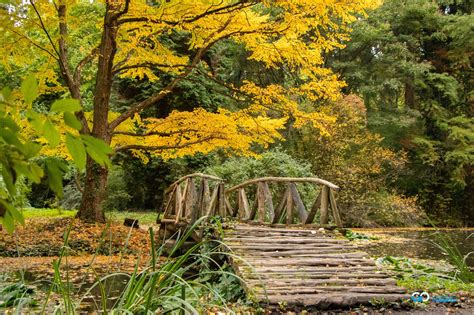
[226, 177, 342, 228]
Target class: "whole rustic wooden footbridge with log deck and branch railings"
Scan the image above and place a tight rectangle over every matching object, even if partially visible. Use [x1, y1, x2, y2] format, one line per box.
[159, 173, 407, 309]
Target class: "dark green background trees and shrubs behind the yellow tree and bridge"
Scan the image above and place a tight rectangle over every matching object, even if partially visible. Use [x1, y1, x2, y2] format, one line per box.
[0, 0, 474, 226]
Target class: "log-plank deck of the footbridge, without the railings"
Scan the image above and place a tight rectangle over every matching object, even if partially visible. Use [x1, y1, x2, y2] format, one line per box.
[224, 224, 408, 309]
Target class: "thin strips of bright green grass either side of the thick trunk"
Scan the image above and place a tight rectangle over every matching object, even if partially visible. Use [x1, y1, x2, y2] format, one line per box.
[17, 208, 157, 224]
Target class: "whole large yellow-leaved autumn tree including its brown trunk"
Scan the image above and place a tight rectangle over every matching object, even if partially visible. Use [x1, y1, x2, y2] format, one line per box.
[0, 0, 376, 221]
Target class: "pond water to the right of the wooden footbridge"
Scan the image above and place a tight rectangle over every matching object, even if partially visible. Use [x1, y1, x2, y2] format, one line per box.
[352, 228, 474, 267]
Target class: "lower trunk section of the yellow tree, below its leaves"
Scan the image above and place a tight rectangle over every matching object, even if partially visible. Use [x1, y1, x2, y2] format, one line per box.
[77, 157, 109, 222]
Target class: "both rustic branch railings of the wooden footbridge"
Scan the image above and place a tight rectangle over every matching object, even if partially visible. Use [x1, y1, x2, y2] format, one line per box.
[161, 173, 342, 228]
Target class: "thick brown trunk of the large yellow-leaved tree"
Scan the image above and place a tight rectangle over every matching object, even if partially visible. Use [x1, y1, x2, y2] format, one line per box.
[77, 3, 120, 222]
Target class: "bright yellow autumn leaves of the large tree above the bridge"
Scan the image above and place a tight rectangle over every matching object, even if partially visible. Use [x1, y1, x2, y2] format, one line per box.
[0, 0, 378, 162]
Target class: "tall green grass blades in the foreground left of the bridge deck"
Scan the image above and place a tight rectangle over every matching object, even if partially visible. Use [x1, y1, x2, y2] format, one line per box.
[16, 218, 252, 315]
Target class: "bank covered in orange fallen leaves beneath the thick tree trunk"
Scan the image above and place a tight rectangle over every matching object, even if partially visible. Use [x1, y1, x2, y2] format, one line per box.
[0, 218, 150, 257]
